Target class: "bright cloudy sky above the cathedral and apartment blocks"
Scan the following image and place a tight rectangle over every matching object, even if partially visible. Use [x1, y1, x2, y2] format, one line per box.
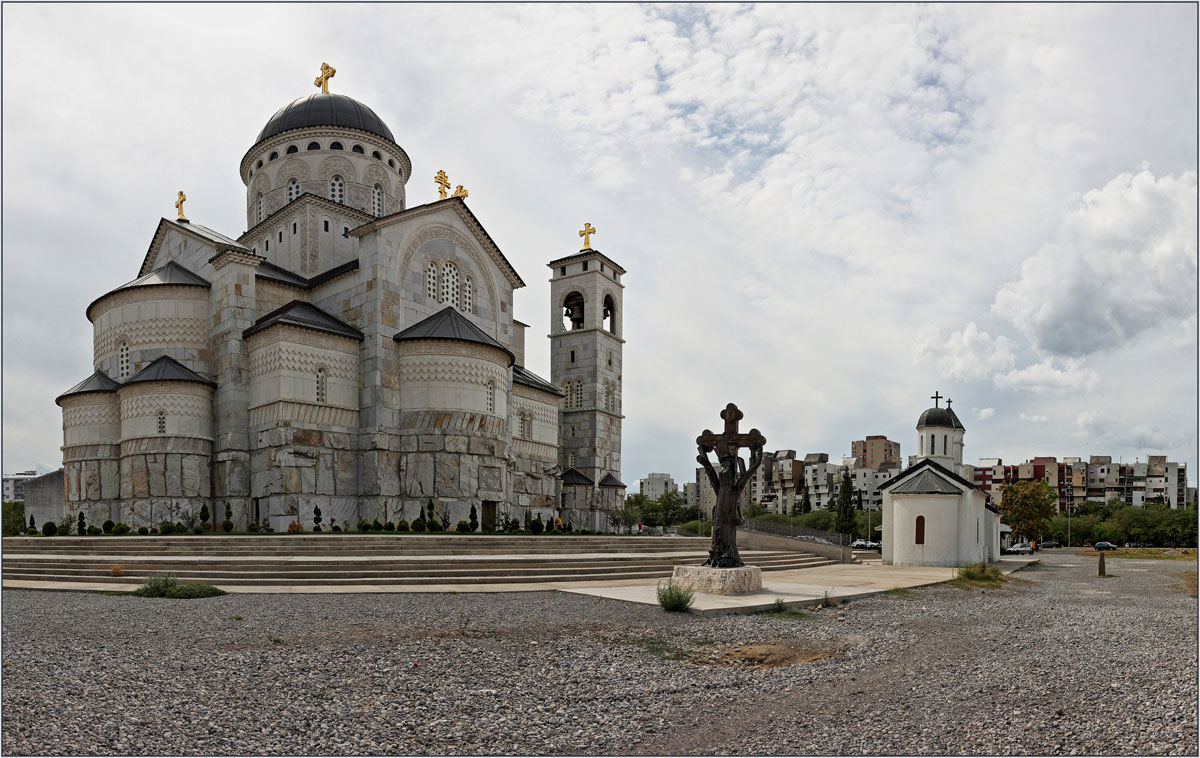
[2, 4, 1198, 483]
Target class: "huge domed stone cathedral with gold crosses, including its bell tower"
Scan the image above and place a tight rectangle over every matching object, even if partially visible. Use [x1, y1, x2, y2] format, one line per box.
[56, 66, 625, 530]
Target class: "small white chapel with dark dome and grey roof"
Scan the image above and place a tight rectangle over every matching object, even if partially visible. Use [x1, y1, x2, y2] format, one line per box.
[880, 392, 1000, 566]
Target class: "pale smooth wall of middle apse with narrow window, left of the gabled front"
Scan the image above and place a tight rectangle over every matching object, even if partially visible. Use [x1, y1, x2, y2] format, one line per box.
[246, 325, 359, 419]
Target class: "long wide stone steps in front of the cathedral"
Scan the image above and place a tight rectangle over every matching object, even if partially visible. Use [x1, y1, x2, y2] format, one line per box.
[2, 535, 834, 589]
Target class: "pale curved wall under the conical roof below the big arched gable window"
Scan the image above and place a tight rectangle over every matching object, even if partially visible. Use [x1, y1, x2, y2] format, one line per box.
[396, 339, 510, 419]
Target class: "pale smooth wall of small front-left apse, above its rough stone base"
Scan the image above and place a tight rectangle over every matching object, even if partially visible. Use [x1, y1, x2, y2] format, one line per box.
[118, 381, 212, 443]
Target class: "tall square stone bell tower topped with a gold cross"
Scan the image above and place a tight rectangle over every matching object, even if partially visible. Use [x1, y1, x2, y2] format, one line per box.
[548, 224, 625, 487]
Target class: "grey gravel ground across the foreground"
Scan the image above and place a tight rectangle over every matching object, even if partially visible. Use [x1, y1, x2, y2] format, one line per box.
[0, 553, 1198, 756]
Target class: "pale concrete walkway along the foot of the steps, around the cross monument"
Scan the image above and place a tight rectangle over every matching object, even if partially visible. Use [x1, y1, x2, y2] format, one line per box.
[4, 557, 1033, 615]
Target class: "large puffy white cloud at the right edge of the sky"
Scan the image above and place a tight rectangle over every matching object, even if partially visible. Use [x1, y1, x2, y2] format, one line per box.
[992, 170, 1196, 356]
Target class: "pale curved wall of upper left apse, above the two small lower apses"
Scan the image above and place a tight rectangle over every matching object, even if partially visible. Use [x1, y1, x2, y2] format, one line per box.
[91, 287, 209, 379]
